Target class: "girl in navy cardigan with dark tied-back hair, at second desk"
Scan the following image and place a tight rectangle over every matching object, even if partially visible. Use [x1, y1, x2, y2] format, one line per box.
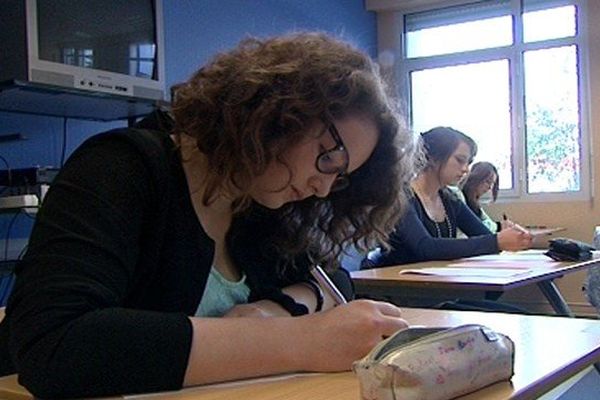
[363, 127, 532, 268]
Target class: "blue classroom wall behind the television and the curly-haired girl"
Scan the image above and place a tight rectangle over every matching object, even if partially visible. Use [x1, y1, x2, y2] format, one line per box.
[0, 0, 376, 259]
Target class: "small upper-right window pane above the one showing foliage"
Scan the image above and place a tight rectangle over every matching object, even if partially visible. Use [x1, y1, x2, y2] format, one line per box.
[523, 6, 577, 43]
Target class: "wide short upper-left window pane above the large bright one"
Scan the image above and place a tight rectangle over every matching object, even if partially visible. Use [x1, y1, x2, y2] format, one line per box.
[406, 15, 513, 58]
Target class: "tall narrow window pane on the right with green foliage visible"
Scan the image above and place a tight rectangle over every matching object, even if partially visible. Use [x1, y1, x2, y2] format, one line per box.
[524, 45, 580, 193]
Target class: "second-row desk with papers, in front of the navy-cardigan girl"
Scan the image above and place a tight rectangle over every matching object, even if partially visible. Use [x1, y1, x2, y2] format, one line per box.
[350, 250, 600, 317]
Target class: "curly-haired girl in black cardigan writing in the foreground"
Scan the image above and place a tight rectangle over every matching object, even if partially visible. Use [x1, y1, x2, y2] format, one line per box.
[0, 33, 415, 398]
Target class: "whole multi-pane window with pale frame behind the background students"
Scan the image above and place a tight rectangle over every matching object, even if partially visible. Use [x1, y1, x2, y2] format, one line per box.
[400, 0, 589, 200]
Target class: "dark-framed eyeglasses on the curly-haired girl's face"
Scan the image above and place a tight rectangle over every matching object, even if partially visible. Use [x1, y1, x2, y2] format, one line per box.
[316, 123, 350, 192]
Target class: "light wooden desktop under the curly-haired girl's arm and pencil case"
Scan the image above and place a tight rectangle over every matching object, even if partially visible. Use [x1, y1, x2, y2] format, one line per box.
[0, 308, 600, 400]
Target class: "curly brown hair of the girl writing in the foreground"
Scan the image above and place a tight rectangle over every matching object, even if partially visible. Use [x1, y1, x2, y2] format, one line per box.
[172, 32, 416, 268]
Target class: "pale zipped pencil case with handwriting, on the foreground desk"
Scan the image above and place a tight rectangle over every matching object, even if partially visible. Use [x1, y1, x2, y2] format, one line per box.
[353, 324, 514, 400]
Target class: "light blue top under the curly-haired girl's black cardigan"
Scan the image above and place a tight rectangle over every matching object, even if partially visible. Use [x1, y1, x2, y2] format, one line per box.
[195, 266, 250, 317]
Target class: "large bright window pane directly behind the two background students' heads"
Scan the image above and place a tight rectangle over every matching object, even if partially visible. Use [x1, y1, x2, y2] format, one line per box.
[410, 60, 513, 189]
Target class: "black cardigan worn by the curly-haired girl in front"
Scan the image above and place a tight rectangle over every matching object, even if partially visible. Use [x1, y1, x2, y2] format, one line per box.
[0, 112, 308, 398]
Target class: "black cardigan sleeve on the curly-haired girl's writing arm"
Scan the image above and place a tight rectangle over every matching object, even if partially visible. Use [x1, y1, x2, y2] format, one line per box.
[7, 133, 192, 398]
